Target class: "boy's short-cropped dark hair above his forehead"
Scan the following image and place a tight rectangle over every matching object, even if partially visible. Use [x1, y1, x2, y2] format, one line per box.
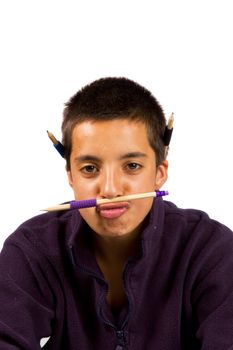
[62, 77, 166, 170]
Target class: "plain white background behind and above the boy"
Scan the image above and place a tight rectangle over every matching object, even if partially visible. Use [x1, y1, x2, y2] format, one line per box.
[0, 0, 233, 247]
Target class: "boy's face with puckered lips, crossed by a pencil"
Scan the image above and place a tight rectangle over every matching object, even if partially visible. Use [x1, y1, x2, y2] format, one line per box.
[68, 119, 168, 237]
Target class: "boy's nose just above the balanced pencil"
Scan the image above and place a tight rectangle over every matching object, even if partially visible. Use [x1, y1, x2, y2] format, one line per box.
[100, 168, 123, 198]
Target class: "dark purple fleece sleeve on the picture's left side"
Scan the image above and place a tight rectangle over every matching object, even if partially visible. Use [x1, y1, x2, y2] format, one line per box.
[0, 235, 54, 350]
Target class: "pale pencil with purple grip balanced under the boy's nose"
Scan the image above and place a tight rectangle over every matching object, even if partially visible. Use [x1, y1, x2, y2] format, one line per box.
[42, 191, 168, 211]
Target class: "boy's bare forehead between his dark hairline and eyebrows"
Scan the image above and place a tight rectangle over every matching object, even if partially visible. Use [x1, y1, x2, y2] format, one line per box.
[72, 119, 151, 149]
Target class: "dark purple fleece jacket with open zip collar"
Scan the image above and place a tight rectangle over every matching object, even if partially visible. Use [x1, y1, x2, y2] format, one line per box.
[0, 198, 233, 350]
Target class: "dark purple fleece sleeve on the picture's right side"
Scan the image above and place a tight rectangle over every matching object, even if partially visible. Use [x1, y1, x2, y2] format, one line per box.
[188, 225, 233, 350]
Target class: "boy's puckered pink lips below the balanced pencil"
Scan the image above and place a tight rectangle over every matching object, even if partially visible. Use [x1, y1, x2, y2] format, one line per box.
[96, 202, 129, 219]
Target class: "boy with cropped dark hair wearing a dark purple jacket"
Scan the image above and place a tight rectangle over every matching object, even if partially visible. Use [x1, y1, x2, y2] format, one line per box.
[0, 78, 233, 350]
